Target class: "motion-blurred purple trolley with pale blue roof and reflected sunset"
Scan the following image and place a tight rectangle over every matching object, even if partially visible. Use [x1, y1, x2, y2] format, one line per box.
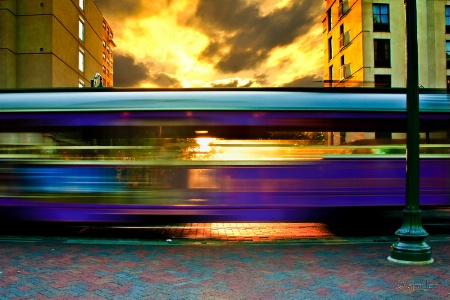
[0, 89, 450, 222]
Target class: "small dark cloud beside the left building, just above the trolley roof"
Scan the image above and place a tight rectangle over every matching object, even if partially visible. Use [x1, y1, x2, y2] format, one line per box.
[114, 52, 148, 87]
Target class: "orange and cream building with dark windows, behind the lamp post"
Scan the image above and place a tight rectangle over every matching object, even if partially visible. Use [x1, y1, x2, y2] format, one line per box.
[323, 0, 450, 88]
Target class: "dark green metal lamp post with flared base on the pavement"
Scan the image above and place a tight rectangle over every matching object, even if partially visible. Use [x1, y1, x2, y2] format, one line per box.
[388, 0, 433, 264]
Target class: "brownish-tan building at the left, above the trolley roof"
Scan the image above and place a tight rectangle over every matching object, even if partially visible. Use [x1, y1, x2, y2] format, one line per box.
[0, 0, 112, 88]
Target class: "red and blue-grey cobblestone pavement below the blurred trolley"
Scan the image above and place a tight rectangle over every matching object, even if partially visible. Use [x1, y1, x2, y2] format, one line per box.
[0, 223, 450, 299]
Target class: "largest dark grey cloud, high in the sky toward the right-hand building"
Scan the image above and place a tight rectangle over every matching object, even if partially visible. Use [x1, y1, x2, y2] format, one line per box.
[192, 0, 320, 72]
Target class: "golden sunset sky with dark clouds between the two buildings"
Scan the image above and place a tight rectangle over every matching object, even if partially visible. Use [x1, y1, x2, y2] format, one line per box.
[95, 0, 325, 88]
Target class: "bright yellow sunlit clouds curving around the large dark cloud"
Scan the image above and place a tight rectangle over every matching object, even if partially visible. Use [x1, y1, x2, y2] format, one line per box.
[108, 0, 323, 87]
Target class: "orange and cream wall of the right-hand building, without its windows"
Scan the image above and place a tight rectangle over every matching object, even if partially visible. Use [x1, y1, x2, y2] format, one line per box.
[323, 0, 450, 88]
